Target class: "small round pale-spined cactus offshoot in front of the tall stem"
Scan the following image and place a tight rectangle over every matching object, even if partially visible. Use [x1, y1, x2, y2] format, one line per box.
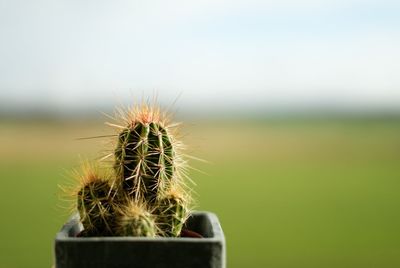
[116, 203, 157, 237]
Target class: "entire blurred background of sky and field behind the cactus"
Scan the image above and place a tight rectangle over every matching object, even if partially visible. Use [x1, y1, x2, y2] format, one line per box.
[0, 0, 400, 268]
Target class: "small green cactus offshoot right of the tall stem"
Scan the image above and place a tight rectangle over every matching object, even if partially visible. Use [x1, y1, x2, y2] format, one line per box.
[157, 195, 189, 237]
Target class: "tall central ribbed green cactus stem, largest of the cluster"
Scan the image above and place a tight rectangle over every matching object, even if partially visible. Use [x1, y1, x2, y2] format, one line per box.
[114, 122, 175, 203]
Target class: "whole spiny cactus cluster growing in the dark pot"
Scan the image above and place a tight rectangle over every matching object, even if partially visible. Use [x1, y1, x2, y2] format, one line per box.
[68, 102, 191, 237]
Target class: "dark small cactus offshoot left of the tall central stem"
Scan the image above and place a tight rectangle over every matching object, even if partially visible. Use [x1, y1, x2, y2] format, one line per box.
[77, 179, 114, 236]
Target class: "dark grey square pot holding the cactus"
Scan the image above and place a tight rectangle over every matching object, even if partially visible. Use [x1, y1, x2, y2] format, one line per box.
[55, 212, 226, 268]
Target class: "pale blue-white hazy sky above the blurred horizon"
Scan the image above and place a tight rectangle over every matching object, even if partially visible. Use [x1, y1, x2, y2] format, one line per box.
[0, 0, 400, 111]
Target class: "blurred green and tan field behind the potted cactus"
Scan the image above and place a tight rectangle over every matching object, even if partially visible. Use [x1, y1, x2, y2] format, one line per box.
[0, 119, 400, 268]
